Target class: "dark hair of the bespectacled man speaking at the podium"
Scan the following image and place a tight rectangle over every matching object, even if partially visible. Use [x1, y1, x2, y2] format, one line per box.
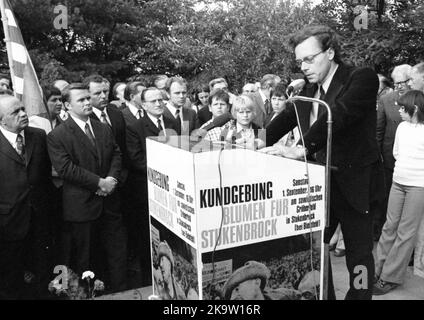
[289, 25, 342, 63]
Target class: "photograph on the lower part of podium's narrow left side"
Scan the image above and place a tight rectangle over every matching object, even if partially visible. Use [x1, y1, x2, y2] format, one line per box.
[150, 218, 199, 300]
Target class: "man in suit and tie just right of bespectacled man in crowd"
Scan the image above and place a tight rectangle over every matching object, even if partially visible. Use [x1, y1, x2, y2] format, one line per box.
[164, 77, 198, 135]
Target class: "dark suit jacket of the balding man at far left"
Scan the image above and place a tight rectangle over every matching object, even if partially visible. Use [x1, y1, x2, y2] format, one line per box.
[0, 127, 51, 241]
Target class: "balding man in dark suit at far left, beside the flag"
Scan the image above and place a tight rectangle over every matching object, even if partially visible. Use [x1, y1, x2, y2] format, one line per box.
[0, 95, 51, 299]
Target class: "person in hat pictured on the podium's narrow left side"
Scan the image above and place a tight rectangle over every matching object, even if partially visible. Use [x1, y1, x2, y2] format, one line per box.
[158, 241, 187, 300]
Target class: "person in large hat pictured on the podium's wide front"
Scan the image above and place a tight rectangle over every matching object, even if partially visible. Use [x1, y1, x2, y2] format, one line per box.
[223, 261, 301, 300]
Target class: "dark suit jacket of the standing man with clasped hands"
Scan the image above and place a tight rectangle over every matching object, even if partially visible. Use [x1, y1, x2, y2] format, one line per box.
[47, 117, 122, 222]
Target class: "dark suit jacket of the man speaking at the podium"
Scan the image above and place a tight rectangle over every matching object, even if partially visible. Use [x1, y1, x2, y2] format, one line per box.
[266, 65, 384, 212]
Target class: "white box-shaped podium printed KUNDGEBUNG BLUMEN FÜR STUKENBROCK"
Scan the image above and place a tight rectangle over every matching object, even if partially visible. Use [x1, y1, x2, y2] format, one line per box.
[146, 136, 325, 300]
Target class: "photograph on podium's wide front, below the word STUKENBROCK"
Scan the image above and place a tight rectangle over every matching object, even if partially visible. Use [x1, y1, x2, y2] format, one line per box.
[202, 231, 321, 300]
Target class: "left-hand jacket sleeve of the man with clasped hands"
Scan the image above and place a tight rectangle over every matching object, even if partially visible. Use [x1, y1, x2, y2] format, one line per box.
[47, 131, 100, 192]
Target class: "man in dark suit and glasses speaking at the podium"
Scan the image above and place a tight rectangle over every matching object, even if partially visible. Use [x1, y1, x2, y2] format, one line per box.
[263, 26, 384, 299]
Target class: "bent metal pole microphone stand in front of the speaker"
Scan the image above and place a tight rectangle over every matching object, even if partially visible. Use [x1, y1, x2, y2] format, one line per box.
[287, 96, 333, 300]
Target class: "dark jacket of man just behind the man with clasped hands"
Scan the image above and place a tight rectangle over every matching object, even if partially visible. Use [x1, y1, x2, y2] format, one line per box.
[90, 104, 128, 183]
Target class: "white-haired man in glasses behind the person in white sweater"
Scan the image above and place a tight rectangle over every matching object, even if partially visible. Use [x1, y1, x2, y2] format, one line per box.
[374, 64, 412, 241]
